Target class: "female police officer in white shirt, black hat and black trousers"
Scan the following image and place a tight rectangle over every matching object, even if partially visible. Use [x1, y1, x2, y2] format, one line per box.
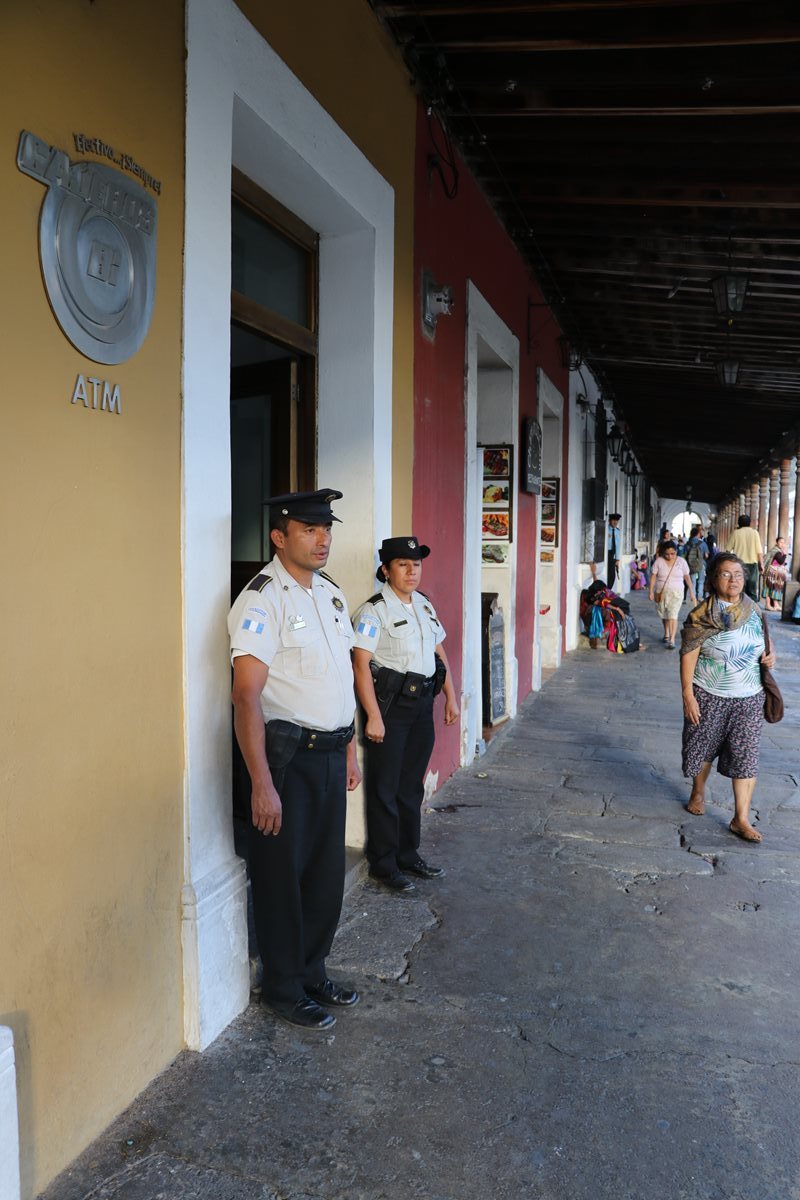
[353, 538, 458, 892]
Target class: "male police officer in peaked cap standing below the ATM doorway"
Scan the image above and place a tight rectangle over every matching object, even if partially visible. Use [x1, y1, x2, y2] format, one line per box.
[228, 488, 361, 1030]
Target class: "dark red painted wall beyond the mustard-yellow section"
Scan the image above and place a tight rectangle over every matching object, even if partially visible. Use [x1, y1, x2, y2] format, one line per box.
[414, 104, 570, 782]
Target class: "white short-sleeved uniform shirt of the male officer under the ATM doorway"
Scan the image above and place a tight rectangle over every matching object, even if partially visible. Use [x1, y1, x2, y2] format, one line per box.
[228, 558, 355, 732]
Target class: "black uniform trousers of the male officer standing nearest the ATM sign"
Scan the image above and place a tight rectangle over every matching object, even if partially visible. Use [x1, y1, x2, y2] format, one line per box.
[249, 746, 347, 1003]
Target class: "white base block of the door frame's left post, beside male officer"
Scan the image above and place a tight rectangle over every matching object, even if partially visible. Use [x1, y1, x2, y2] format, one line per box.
[181, 857, 249, 1050]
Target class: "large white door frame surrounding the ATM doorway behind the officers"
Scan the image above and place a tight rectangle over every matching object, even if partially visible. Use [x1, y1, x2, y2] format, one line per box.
[182, 0, 395, 1049]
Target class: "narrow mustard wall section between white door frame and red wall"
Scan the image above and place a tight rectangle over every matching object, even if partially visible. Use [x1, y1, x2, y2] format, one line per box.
[239, 0, 416, 533]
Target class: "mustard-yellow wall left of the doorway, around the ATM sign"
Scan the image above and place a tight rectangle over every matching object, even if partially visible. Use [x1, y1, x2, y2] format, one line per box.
[0, 0, 185, 1196]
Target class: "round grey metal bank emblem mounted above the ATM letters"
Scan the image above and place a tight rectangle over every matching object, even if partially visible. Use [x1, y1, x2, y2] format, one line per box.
[17, 131, 157, 362]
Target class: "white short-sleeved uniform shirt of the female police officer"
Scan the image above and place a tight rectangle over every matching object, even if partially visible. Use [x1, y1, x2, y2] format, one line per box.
[353, 583, 446, 678]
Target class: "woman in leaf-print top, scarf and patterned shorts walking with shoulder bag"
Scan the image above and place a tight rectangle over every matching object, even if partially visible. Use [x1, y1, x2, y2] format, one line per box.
[680, 551, 775, 841]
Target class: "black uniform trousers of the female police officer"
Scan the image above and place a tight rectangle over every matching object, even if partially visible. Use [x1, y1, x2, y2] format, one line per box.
[365, 695, 434, 876]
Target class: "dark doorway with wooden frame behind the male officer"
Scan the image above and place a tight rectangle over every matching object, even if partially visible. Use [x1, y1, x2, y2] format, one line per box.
[230, 172, 318, 820]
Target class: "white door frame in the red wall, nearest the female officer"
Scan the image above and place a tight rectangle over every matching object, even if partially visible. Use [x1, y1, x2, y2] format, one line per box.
[461, 280, 519, 766]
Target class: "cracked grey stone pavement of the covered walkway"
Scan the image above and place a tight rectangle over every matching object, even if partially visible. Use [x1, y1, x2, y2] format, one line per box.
[44, 594, 800, 1200]
